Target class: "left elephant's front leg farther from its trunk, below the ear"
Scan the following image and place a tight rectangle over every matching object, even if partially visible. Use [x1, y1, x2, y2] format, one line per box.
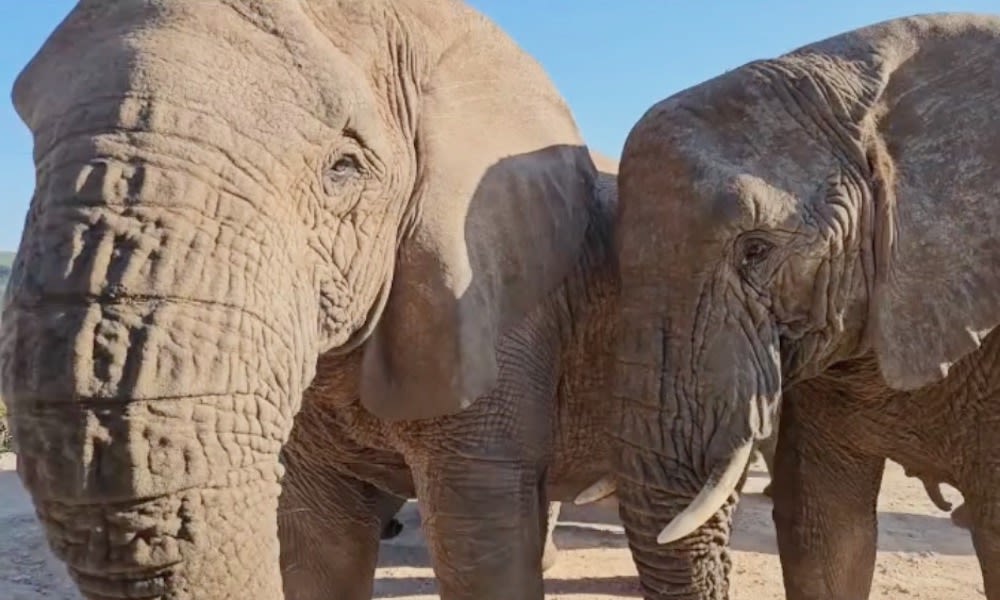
[411, 456, 545, 600]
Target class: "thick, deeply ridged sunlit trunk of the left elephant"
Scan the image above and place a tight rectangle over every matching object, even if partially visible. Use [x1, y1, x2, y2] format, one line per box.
[0, 155, 316, 599]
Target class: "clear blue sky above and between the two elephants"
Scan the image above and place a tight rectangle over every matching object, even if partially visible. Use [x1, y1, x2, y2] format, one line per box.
[0, 0, 1000, 250]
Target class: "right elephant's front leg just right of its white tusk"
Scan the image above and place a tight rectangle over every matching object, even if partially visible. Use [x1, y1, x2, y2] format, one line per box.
[773, 390, 885, 600]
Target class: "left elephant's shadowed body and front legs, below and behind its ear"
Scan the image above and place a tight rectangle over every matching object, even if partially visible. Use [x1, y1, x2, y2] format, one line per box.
[278, 268, 616, 600]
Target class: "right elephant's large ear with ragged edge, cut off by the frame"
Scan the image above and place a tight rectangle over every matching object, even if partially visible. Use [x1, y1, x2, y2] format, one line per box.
[856, 17, 1000, 390]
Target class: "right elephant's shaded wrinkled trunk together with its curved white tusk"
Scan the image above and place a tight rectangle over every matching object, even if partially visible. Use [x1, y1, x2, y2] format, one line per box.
[615, 302, 780, 600]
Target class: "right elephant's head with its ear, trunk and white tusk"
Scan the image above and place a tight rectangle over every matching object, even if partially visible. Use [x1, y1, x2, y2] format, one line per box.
[614, 15, 1000, 598]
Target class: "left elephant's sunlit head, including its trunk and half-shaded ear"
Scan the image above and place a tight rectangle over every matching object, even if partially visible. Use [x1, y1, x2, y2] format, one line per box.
[0, 0, 596, 599]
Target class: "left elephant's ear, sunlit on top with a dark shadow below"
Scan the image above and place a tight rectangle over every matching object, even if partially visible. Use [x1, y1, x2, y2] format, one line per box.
[361, 19, 596, 420]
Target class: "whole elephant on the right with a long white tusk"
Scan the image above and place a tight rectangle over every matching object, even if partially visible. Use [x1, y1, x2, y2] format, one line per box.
[611, 13, 1000, 600]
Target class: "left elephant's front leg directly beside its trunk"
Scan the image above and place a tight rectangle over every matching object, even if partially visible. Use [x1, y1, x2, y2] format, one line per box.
[278, 459, 390, 600]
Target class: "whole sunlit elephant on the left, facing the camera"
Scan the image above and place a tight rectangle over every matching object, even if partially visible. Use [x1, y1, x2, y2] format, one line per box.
[0, 0, 617, 600]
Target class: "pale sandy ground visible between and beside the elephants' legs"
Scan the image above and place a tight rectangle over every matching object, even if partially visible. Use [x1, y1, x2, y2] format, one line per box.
[0, 454, 984, 600]
